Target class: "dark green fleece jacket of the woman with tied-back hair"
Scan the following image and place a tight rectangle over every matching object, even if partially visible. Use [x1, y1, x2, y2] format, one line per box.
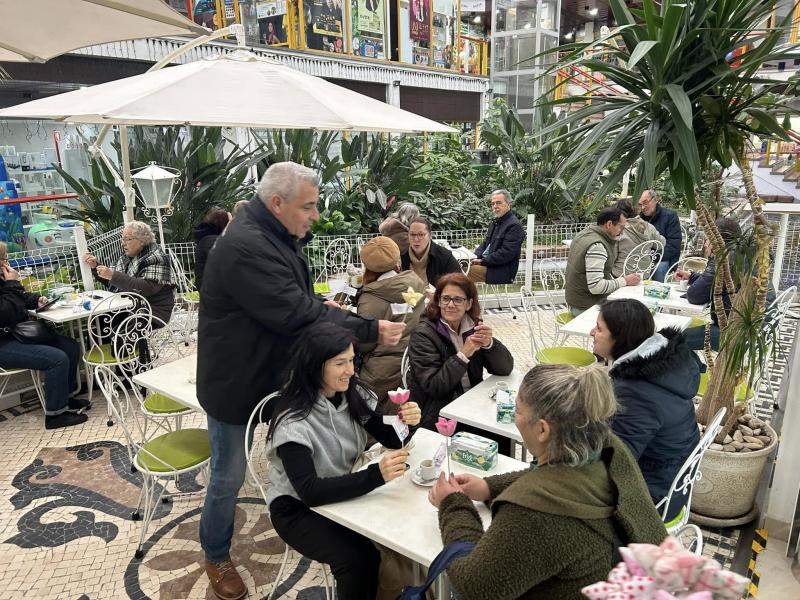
[439, 434, 667, 600]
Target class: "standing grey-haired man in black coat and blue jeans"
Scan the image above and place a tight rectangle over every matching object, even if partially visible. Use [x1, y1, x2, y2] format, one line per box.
[197, 162, 405, 600]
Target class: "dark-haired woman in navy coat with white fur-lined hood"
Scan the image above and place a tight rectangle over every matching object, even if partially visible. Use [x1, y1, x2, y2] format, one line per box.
[592, 299, 700, 503]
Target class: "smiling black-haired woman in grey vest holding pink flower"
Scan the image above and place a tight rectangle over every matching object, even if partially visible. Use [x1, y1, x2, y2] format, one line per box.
[266, 323, 420, 600]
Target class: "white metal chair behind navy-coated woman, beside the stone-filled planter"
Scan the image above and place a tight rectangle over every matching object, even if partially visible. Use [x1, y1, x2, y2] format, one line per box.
[656, 408, 725, 554]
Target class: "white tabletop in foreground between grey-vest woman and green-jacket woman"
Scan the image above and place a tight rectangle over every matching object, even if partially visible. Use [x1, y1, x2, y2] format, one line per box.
[311, 429, 528, 567]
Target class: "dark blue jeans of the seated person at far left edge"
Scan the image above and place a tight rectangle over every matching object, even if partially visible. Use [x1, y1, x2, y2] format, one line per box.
[0, 335, 81, 415]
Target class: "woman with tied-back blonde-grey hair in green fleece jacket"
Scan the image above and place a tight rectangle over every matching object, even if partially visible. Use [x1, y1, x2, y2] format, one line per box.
[429, 365, 667, 600]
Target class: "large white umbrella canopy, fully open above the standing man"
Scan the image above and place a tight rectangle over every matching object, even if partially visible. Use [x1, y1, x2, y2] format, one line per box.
[0, 50, 456, 133]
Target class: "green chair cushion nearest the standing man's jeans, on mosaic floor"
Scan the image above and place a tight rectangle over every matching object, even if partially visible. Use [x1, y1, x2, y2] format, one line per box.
[136, 429, 211, 473]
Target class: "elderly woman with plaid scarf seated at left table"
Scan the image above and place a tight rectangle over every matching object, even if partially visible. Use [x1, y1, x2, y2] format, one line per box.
[83, 221, 175, 325]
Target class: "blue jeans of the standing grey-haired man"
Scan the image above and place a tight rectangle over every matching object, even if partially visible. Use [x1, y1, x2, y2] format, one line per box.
[200, 415, 252, 563]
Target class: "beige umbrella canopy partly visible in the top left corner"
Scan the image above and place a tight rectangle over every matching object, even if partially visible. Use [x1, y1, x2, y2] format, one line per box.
[0, 0, 208, 62]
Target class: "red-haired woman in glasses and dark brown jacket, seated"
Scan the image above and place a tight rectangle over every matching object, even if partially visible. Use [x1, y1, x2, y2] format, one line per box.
[408, 273, 514, 435]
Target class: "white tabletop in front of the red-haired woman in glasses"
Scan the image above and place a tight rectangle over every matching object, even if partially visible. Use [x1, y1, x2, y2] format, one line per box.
[439, 371, 523, 442]
